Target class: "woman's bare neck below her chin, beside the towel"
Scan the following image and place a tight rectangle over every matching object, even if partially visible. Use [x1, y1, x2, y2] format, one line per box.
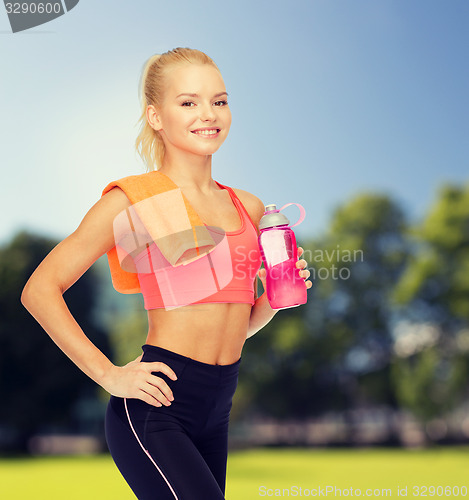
[158, 146, 217, 194]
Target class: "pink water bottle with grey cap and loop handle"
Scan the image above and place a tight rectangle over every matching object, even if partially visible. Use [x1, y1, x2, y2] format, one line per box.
[259, 203, 308, 309]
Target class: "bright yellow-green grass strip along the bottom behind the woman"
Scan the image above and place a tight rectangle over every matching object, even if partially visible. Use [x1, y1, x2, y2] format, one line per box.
[0, 446, 469, 500]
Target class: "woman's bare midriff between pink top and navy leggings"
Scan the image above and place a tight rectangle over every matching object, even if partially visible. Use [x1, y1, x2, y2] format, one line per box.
[146, 303, 252, 365]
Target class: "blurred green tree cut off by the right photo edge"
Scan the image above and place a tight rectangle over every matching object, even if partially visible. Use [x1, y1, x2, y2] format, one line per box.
[392, 185, 469, 430]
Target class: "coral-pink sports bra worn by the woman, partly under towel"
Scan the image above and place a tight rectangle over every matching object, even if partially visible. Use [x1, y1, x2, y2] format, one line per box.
[136, 181, 262, 310]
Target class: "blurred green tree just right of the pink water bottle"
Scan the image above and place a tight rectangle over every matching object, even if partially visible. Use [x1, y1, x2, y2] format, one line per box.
[240, 194, 409, 428]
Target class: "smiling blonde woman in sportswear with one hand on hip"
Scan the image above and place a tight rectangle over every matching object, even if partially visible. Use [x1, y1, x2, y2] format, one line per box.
[21, 48, 311, 500]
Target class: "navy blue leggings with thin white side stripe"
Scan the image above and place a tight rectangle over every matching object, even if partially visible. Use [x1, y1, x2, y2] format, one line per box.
[105, 344, 241, 500]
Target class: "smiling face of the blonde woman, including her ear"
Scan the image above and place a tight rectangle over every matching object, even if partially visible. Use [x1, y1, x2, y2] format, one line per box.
[147, 64, 231, 155]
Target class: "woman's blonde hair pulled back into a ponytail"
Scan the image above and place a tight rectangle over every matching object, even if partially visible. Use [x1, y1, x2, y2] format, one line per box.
[135, 47, 220, 171]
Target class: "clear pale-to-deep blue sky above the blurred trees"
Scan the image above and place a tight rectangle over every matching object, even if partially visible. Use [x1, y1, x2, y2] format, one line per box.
[0, 0, 469, 243]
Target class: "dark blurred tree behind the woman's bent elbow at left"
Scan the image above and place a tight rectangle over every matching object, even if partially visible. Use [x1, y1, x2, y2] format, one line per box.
[0, 231, 110, 451]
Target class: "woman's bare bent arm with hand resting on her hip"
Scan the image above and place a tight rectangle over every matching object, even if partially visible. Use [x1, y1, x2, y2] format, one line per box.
[21, 188, 176, 406]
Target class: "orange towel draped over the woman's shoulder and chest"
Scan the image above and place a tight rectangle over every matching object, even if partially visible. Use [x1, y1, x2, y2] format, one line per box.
[102, 170, 216, 293]
